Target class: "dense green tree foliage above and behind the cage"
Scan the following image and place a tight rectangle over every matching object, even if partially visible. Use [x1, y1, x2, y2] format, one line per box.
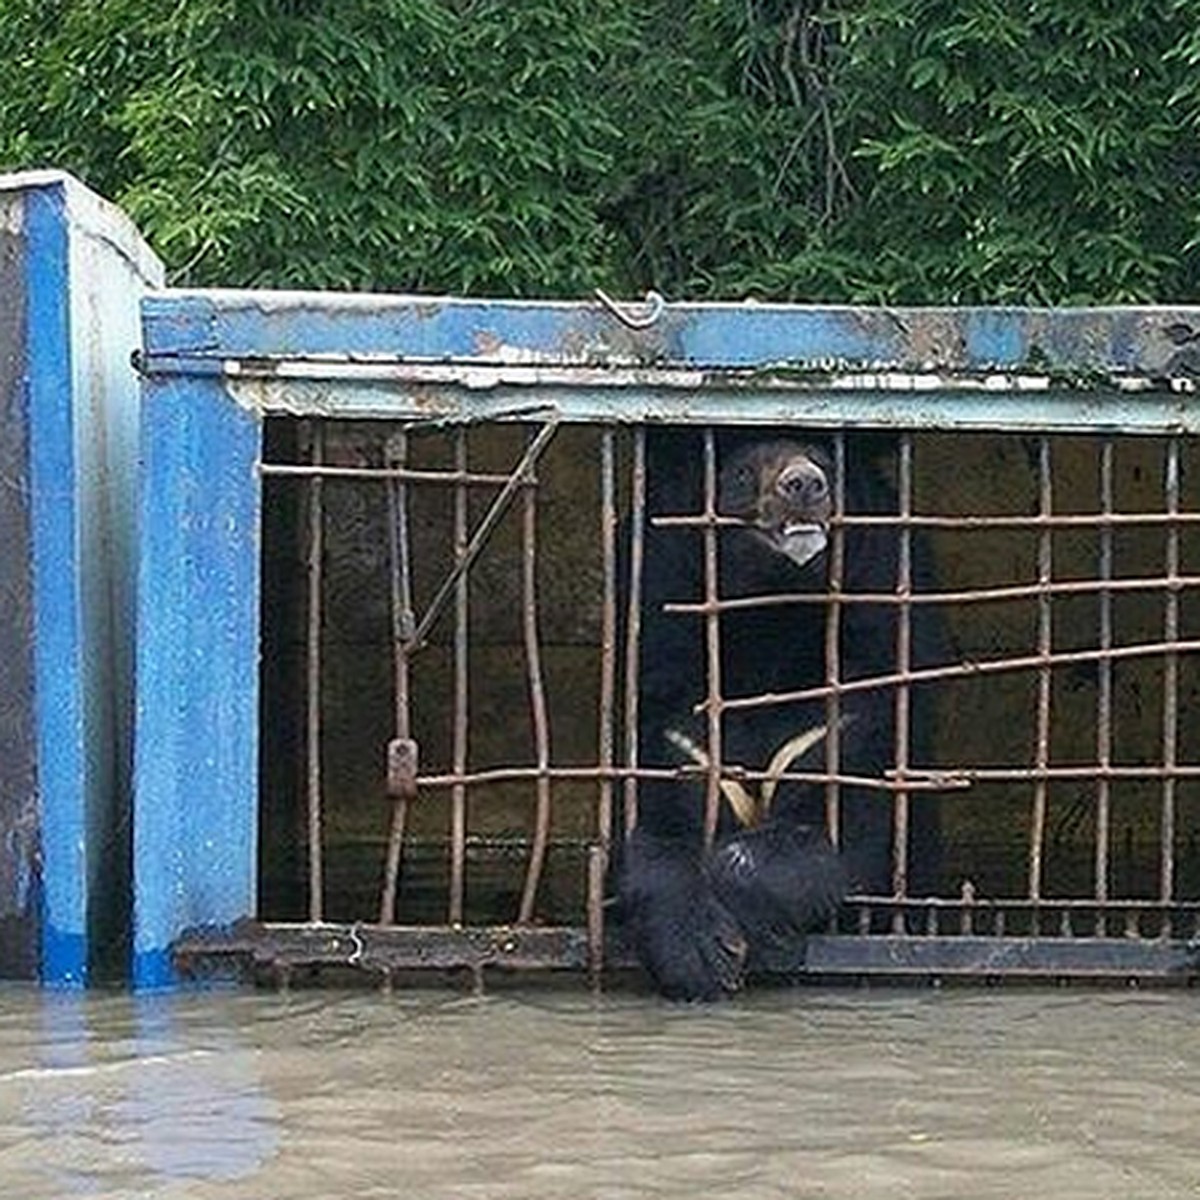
[0, 0, 1200, 304]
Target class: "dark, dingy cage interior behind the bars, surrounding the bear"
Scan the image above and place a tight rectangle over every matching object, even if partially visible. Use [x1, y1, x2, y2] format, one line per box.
[248, 418, 1200, 979]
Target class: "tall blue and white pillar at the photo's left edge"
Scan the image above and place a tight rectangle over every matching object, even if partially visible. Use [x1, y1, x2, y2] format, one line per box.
[0, 173, 161, 985]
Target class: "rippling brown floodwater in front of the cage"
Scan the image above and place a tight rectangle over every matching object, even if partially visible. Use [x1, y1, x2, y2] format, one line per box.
[0, 990, 1200, 1200]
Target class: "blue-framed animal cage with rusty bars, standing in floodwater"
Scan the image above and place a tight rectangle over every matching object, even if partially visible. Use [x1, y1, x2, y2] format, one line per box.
[129, 293, 1200, 983]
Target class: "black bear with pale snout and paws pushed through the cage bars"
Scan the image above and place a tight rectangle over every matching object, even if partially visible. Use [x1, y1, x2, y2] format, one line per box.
[620, 430, 940, 1000]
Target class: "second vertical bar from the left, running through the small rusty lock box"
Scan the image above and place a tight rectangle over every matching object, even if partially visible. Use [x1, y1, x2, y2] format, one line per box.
[379, 432, 414, 925]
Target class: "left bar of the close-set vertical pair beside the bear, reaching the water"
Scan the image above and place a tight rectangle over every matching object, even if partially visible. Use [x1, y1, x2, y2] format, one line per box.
[588, 428, 617, 983]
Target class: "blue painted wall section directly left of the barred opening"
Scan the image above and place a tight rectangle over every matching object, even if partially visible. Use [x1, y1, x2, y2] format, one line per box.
[133, 378, 262, 986]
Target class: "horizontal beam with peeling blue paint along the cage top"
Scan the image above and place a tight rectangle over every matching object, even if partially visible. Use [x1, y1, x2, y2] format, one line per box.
[144, 292, 1200, 373]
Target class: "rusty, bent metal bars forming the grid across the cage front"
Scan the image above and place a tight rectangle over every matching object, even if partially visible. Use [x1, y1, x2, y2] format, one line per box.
[263, 422, 1200, 978]
